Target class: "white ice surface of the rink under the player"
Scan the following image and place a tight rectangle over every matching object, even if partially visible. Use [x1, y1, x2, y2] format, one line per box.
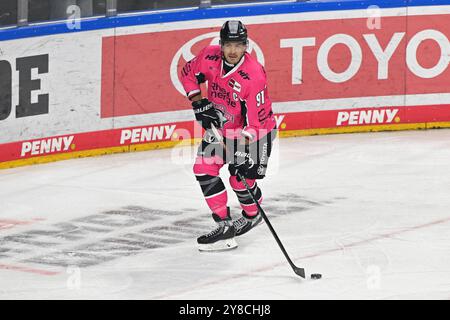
[0, 130, 450, 299]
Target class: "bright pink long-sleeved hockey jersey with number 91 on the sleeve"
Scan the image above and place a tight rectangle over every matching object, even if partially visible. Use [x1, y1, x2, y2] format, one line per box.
[181, 46, 276, 139]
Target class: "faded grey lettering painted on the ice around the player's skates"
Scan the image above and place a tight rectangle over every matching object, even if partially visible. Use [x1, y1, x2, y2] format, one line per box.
[0, 194, 332, 268]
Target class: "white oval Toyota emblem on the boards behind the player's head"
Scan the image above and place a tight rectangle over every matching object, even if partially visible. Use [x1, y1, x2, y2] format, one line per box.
[170, 32, 265, 96]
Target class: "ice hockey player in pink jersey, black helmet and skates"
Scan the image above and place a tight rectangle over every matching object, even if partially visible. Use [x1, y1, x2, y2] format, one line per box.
[181, 20, 276, 251]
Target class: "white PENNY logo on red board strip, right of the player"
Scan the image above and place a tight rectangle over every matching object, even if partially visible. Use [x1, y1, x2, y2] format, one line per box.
[336, 109, 400, 126]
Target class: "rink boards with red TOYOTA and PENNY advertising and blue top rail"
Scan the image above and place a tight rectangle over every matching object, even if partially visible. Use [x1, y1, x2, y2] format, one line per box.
[0, 1, 450, 168]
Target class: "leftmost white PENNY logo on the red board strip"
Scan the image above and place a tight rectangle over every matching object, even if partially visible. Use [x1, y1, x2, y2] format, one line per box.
[20, 136, 74, 157]
